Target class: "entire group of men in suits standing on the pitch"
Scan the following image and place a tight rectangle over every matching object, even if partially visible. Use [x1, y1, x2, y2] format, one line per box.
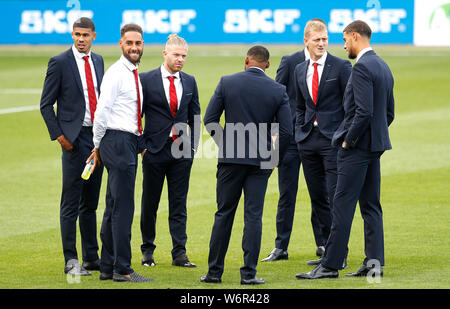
[41, 17, 394, 284]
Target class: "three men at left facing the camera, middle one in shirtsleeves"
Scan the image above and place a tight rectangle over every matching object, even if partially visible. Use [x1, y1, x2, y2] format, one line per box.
[41, 17, 200, 282]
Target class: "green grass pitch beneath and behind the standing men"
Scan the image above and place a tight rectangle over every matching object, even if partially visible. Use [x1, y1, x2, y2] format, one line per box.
[0, 45, 450, 289]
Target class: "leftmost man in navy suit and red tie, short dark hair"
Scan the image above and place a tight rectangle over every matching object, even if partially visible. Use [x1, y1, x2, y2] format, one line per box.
[40, 17, 104, 275]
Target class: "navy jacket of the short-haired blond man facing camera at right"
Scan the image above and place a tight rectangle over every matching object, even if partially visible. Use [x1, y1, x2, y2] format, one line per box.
[295, 53, 352, 143]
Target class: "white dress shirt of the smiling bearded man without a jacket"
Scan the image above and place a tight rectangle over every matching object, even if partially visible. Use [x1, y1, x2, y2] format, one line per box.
[93, 55, 143, 148]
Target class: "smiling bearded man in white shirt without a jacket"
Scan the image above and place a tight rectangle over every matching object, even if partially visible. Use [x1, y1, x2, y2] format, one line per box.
[88, 24, 153, 282]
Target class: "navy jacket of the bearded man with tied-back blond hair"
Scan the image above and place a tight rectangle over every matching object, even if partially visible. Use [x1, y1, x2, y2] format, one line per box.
[139, 67, 201, 158]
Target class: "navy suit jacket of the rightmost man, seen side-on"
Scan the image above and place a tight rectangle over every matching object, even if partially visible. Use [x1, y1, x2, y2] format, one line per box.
[332, 51, 394, 152]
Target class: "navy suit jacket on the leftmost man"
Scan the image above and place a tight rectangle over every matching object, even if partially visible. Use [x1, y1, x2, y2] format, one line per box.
[40, 48, 104, 143]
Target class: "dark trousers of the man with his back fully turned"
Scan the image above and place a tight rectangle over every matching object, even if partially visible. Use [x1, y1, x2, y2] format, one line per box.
[208, 163, 271, 279]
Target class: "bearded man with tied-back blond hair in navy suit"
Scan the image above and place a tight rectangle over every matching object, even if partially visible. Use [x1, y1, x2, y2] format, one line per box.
[140, 34, 201, 267]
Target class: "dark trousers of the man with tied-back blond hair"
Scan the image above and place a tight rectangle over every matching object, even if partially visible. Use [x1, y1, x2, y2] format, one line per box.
[141, 143, 192, 258]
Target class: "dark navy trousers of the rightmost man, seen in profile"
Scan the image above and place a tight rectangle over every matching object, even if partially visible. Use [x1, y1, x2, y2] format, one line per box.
[322, 148, 384, 269]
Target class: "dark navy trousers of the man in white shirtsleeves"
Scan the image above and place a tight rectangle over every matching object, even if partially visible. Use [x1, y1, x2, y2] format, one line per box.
[100, 130, 138, 275]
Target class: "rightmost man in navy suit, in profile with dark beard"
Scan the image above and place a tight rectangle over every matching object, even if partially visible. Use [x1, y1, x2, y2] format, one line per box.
[297, 20, 394, 279]
